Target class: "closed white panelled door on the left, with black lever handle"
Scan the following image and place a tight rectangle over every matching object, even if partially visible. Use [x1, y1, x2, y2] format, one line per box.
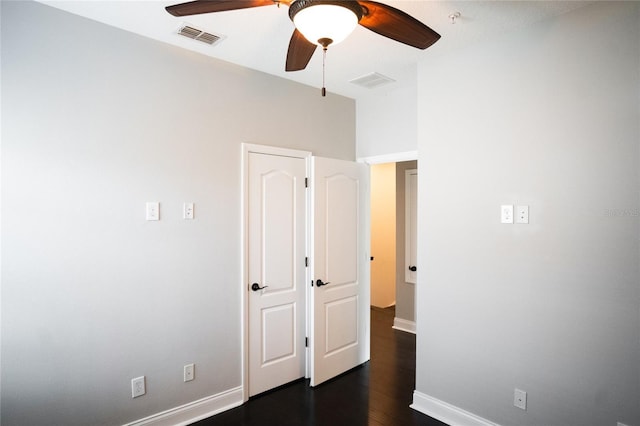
[247, 152, 306, 396]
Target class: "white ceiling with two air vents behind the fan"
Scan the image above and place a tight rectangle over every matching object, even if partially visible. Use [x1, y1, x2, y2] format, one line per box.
[40, 0, 593, 99]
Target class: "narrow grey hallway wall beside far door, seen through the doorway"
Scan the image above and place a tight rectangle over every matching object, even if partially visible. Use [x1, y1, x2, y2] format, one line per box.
[396, 161, 420, 321]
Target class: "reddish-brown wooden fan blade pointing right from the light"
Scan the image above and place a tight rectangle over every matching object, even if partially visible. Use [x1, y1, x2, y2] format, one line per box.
[358, 0, 440, 49]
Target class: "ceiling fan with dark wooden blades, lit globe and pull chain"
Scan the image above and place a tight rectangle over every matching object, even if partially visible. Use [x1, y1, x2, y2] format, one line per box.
[166, 0, 440, 96]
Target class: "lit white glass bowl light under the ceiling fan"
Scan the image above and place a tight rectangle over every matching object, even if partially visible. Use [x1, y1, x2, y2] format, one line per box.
[289, 0, 362, 47]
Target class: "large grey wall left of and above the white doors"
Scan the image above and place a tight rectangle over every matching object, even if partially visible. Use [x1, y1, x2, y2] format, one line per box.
[1, 1, 355, 426]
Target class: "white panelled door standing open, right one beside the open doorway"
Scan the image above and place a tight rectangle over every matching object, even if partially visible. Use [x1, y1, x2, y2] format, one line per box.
[310, 157, 370, 386]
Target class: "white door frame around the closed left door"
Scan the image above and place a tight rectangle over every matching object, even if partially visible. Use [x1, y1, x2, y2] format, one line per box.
[238, 143, 312, 402]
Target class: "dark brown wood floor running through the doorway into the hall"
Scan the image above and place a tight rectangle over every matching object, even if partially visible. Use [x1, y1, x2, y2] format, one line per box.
[195, 308, 446, 426]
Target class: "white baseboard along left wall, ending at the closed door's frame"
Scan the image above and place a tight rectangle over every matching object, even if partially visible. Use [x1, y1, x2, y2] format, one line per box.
[124, 387, 244, 426]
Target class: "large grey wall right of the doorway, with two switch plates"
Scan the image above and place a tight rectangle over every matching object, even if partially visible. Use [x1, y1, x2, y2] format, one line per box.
[416, 2, 640, 426]
